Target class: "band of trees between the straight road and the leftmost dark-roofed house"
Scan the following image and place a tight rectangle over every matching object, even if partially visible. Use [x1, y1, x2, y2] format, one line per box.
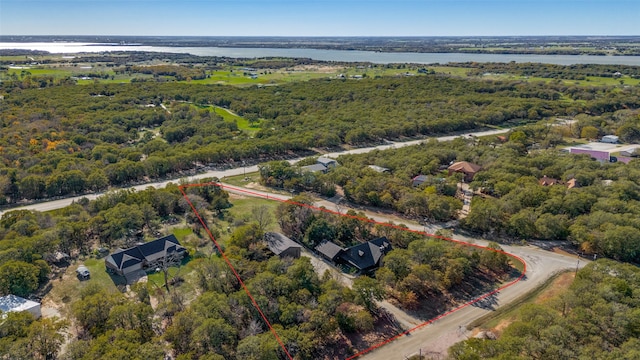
[0, 179, 230, 297]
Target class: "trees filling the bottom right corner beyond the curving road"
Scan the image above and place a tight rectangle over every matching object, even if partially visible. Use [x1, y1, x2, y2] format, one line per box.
[449, 260, 640, 360]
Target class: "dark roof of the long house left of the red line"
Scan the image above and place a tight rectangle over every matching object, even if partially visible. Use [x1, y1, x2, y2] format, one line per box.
[105, 234, 185, 270]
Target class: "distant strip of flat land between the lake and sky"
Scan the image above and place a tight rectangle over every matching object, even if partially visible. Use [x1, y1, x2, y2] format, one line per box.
[0, 35, 640, 56]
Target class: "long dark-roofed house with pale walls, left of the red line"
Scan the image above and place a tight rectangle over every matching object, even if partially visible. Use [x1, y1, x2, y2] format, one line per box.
[104, 235, 187, 282]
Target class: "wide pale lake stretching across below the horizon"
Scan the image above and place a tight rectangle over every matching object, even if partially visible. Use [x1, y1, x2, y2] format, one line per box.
[0, 42, 640, 66]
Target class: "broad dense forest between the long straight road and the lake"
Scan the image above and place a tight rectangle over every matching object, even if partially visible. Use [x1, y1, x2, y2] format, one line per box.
[5, 70, 640, 203]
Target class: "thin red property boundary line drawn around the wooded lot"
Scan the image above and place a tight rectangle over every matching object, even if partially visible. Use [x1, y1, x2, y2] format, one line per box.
[178, 182, 527, 360]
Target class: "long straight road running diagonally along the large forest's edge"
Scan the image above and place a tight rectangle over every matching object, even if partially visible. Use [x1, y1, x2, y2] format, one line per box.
[0, 129, 509, 218]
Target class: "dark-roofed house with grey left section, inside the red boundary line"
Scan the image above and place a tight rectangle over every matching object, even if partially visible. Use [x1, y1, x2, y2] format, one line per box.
[315, 237, 393, 273]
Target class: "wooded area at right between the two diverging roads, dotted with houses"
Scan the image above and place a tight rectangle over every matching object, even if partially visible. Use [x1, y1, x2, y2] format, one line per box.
[260, 110, 640, 262]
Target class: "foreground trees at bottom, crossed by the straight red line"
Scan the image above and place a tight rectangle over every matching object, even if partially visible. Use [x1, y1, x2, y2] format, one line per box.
[64, 256, 384, 360]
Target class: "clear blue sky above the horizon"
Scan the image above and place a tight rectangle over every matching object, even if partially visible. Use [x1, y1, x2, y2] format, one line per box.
[0, 0, 640, 36]
